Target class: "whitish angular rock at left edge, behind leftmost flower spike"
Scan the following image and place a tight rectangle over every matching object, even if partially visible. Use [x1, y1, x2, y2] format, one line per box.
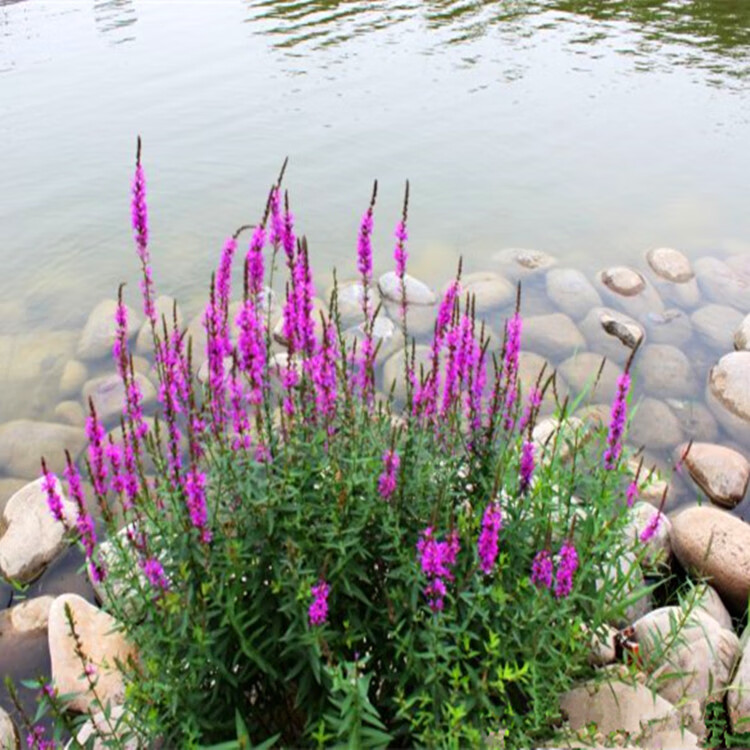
[0, 479, 77, 583]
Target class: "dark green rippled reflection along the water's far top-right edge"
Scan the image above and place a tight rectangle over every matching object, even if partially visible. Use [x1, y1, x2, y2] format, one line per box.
[244, 0, 750, 83]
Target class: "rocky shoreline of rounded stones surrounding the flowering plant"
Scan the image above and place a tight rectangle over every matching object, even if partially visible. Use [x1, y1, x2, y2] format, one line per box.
[0, 248, 750, 747]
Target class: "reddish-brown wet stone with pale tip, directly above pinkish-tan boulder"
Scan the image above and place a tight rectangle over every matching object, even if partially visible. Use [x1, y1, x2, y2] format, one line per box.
[675, 443, 750, 508]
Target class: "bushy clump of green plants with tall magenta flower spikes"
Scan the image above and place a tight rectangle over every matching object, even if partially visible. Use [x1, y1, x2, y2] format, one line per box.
[17, 146, 660, 748]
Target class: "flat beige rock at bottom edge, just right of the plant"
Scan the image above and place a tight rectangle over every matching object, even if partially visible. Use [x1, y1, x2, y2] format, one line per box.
[560, 679, 700, 750]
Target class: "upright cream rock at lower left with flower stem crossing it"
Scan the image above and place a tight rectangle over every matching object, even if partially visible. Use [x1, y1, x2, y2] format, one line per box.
[48, 594, 136, 712]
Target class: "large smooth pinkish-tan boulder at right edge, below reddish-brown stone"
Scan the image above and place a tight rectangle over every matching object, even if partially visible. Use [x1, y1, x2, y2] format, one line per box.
[671, 505, 750, 614]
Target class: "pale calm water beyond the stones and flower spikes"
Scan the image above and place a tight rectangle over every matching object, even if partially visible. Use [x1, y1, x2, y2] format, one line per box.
[0, 0, 750, 724]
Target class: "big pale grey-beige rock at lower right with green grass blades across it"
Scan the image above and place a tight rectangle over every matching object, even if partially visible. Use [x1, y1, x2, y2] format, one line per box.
[633, 607, 740, 735]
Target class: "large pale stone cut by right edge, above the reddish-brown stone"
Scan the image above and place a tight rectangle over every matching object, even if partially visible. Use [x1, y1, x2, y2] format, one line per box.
[706, 352, 750, 444]
